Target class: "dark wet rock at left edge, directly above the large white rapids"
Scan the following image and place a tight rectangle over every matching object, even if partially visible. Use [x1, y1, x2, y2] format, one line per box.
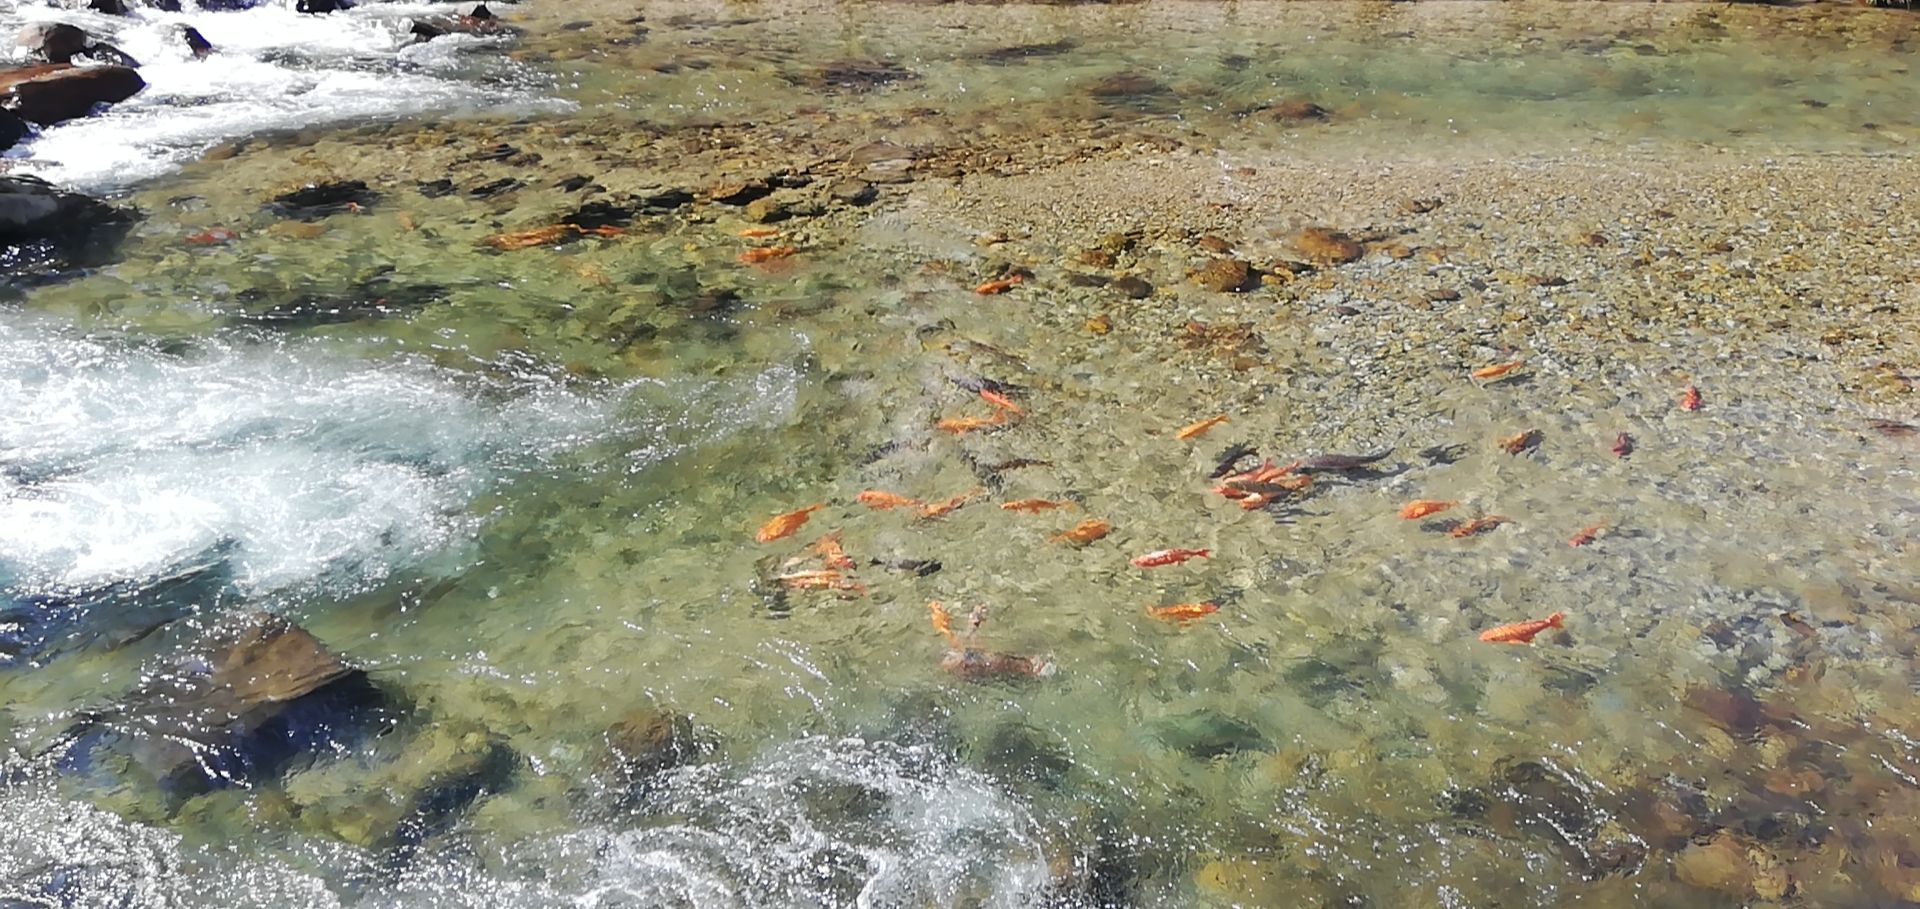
[0, 177, 136, 277]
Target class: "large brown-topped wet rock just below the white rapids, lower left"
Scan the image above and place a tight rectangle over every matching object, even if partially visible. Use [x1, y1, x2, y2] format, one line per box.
[60, 613, 386, 798]
